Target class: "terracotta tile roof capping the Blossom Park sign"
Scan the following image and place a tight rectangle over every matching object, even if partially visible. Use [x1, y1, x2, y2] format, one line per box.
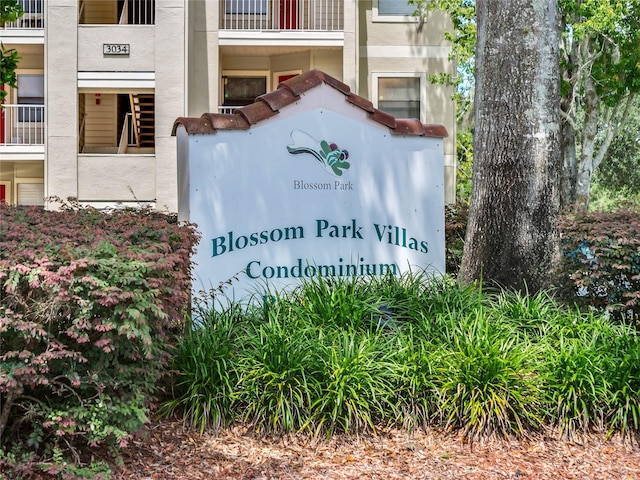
[172, 70, 448, 137]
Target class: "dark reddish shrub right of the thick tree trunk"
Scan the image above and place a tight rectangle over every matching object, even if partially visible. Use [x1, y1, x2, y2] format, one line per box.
[560, 209, 640, 321]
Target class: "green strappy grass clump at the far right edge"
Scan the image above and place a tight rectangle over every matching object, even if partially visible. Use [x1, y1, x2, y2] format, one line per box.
[544, 314, 640, 438]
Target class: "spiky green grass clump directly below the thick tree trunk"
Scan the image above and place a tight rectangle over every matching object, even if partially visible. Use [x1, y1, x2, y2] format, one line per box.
[436, 311, 543, 438]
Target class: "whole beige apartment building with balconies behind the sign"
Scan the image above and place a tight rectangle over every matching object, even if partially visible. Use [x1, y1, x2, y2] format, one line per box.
[0, 0, 455, 211]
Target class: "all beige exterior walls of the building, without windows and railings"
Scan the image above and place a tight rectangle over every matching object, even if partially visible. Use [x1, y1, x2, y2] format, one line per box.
[5, 0, 455, 211]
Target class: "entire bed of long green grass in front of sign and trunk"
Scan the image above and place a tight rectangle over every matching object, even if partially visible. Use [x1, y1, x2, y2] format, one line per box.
[166, 273, 640, 440]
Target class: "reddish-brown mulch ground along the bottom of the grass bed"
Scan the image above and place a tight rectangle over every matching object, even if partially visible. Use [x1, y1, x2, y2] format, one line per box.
[115, 420, 640, 480]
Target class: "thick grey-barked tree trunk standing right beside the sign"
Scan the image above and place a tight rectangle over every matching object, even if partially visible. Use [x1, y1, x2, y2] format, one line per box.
[460, 0, 562, 292]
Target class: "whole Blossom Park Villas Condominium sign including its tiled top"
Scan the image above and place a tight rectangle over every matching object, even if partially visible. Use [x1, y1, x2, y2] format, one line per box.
[174, 71, 446, 300]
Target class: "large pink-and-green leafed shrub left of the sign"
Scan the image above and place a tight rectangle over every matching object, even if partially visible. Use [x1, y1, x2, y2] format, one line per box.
[0, 203, 196, 469]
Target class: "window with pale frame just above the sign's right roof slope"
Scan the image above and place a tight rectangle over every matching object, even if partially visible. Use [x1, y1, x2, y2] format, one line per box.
[373, 74, 422, 119]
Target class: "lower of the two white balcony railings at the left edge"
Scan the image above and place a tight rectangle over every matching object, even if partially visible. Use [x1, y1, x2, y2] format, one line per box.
[0, 105, 44, 145]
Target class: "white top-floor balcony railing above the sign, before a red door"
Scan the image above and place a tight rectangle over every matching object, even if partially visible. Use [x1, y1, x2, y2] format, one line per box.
[220, 0, 344, 32]
